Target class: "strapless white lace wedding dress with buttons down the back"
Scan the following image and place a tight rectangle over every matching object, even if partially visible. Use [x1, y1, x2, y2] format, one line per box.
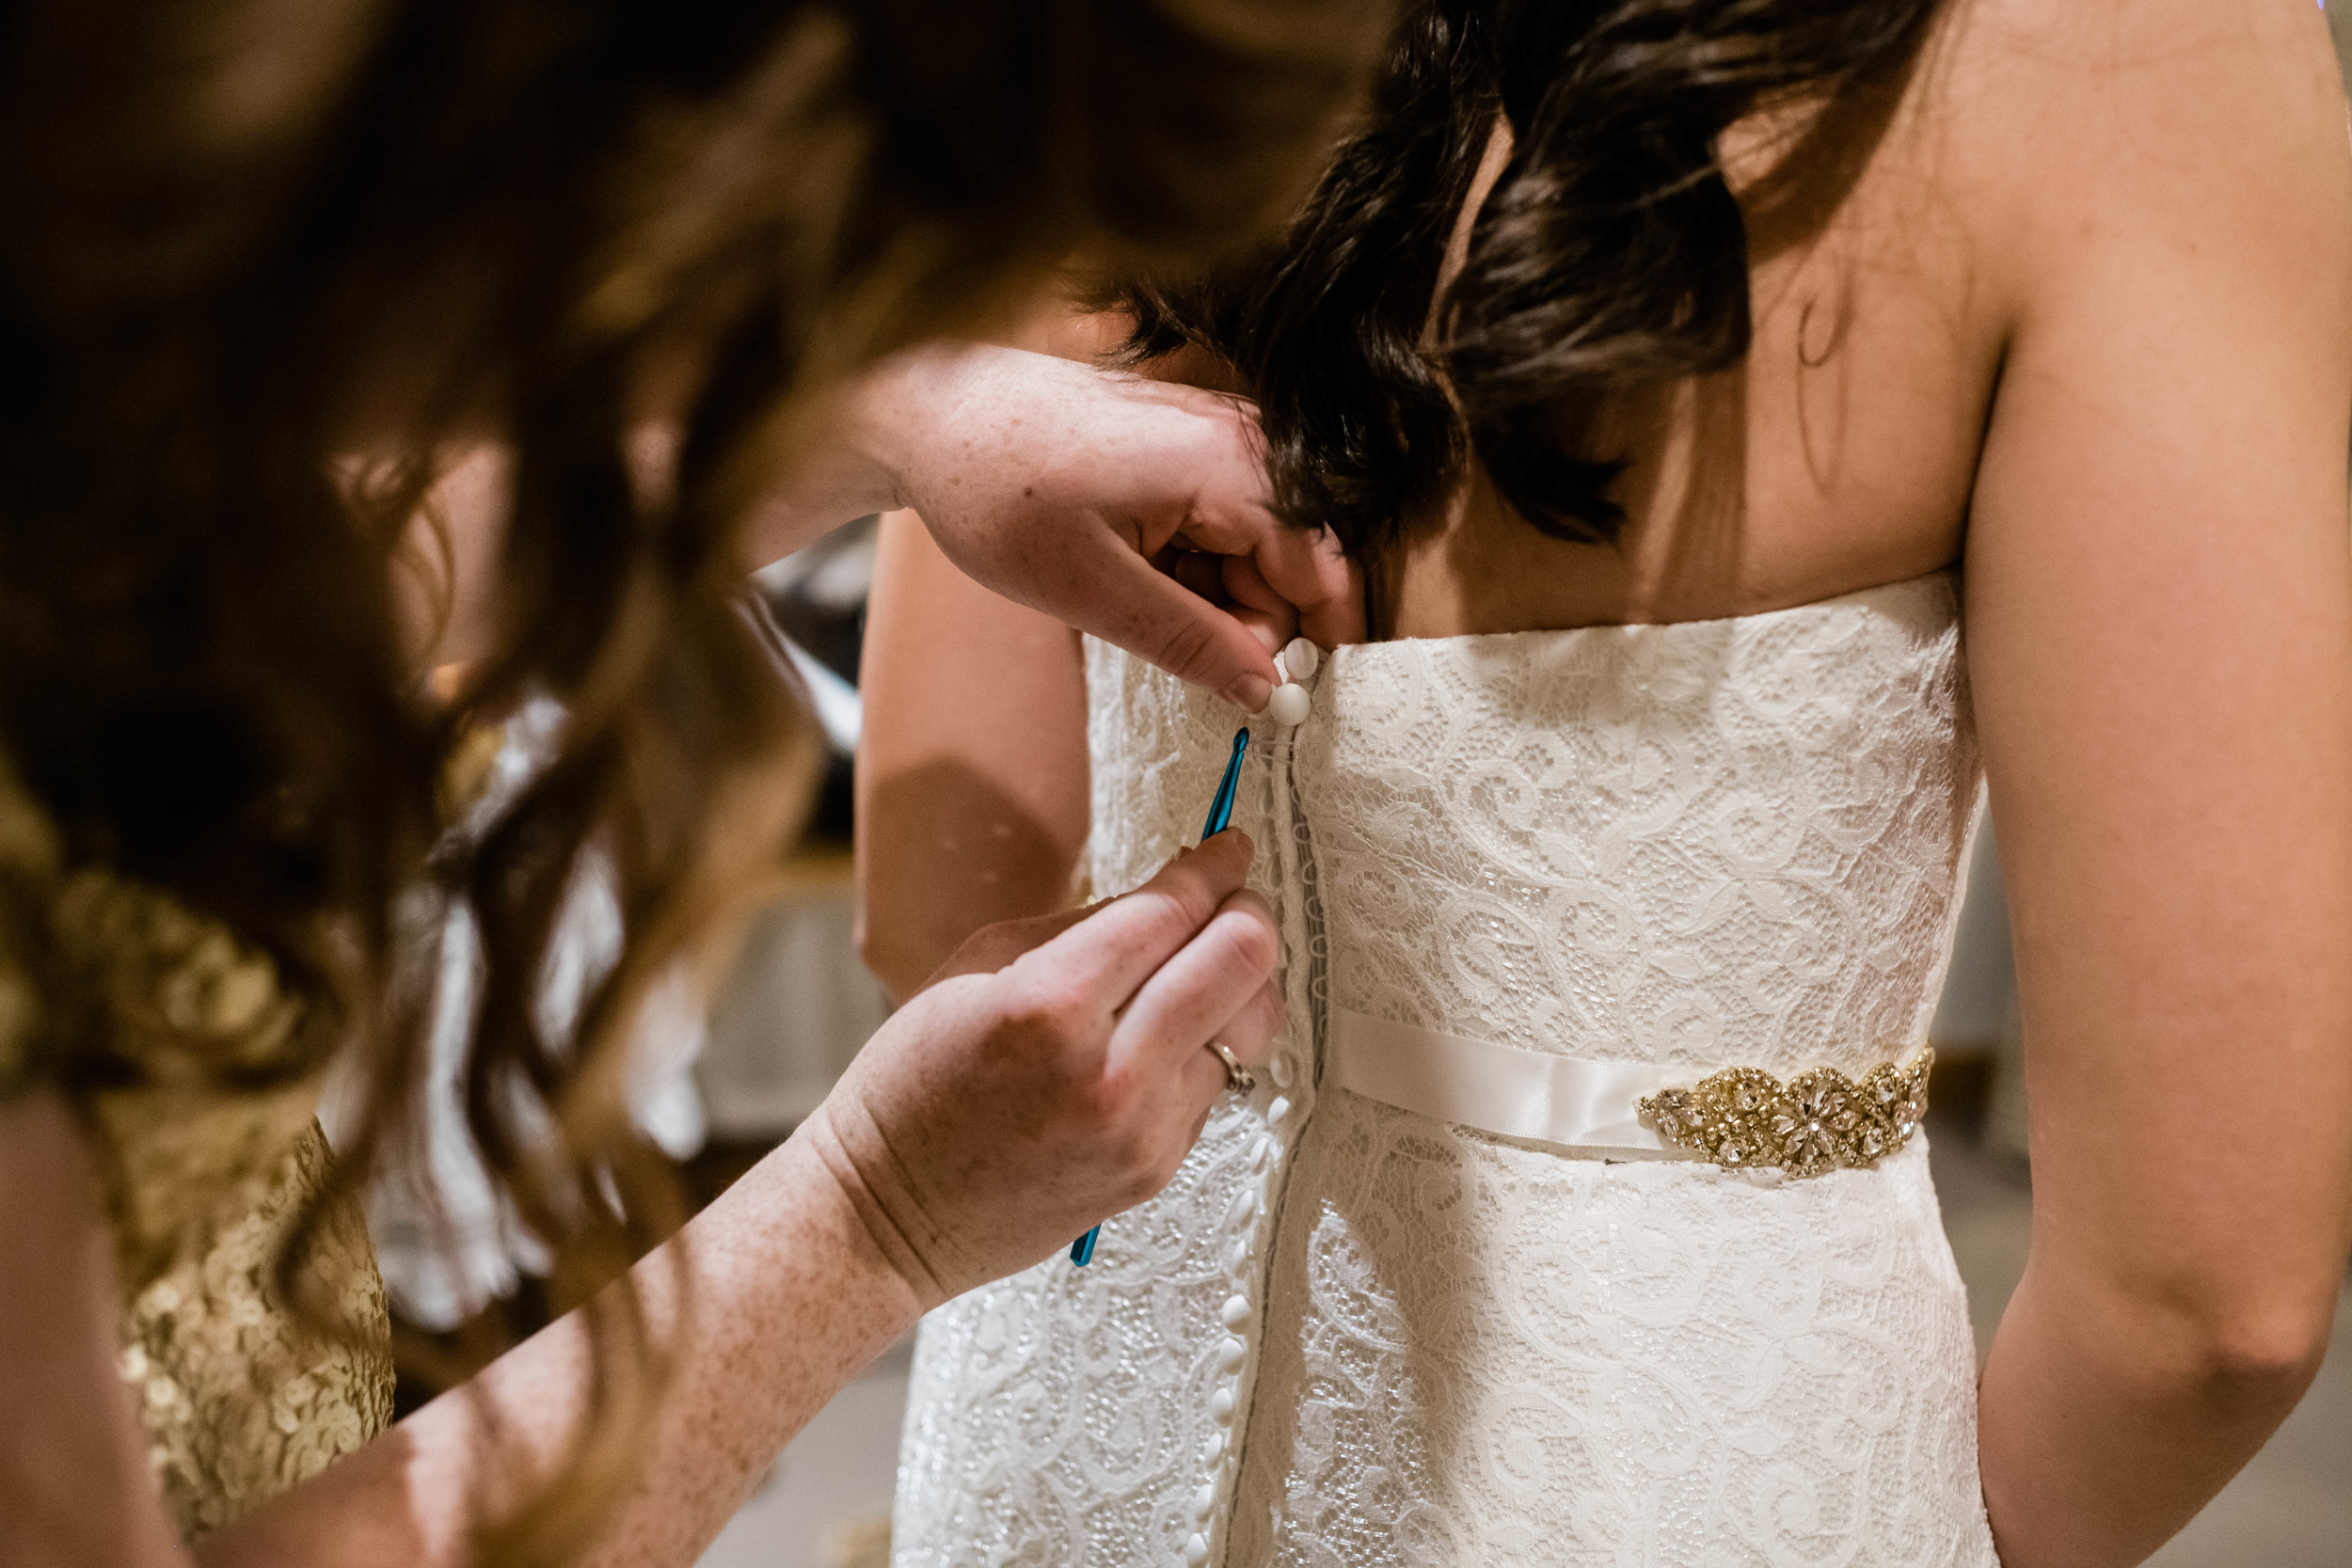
[894, 576, 1994, 1568]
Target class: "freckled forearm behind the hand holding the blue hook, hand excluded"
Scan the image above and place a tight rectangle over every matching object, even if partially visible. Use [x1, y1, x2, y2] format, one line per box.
[200, 1140, 920, 1568]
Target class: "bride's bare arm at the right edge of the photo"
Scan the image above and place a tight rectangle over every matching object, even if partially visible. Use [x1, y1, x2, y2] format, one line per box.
[1966, 0, 2352, 1568]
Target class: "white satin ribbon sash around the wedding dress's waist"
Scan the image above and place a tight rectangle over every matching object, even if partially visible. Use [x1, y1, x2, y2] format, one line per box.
[1325, 1008, 1703, 1159]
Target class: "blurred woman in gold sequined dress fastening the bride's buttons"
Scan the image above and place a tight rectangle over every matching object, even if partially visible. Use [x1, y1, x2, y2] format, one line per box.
[0, 0, 1367, 1566]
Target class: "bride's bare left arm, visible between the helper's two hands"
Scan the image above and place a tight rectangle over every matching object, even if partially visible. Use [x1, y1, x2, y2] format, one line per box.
[856, 513, 1087, 997]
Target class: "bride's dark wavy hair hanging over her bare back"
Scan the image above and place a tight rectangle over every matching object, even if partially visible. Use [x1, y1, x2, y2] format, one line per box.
[1105, 0, 1941, 576]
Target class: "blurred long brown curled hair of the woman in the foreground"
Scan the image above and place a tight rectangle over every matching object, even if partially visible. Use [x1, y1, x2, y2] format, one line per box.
[0, 0, 1386, 1561]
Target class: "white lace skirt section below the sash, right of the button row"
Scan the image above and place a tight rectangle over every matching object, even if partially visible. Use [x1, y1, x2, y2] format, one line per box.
[1232, 1114, 1994, 1568]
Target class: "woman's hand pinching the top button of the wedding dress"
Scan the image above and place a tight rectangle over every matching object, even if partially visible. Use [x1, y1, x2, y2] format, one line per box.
[851, 345, 1364, 712]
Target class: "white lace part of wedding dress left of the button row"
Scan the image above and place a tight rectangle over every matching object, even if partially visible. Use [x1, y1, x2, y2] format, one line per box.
[892, 644, 1306, 1566]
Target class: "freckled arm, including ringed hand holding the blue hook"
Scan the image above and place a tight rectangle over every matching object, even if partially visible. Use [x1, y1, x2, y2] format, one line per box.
[0, 832, 1279, 1568]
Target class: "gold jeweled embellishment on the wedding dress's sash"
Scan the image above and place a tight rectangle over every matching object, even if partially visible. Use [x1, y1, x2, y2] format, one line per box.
[1642, 1046, 1936, 1176]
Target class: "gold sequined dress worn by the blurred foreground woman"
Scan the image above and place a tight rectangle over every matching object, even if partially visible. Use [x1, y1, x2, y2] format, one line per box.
[0, 759, 393, 1540]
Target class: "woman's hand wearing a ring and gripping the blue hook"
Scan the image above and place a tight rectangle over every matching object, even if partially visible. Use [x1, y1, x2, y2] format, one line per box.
[803, 832, 1282, 1307]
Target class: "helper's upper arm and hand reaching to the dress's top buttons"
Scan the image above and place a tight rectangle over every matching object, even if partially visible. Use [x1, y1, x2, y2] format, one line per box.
[398, 343, 1362, 712]
